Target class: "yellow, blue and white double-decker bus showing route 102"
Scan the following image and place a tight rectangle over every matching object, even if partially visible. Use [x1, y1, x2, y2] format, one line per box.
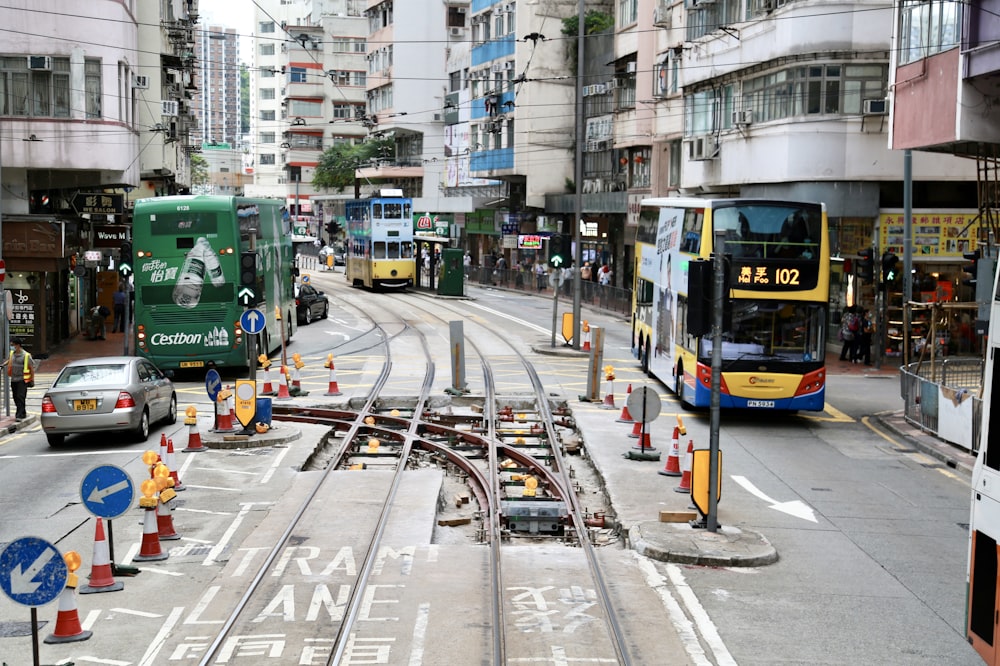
[632, 198, 830, 411]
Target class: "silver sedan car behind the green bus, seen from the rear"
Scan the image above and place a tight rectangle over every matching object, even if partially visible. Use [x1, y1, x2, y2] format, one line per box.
[41, 356, 177, 446]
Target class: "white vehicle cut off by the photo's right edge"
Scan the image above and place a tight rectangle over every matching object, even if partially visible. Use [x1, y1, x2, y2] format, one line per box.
[966, 264, 1000, 664]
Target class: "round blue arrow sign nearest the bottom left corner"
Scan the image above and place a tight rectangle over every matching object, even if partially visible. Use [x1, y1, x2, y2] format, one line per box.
[0, 537, 69, 607]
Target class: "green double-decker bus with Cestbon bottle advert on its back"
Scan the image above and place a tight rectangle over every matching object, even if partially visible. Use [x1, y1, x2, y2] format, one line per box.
[132, 196, 297, 369]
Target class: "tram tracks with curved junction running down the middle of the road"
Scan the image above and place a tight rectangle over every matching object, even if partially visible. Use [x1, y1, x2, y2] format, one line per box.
[194, 294, 631, 665]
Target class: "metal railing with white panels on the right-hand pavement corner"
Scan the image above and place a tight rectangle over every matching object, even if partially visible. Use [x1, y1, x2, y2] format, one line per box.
[899, 357, 984, 455]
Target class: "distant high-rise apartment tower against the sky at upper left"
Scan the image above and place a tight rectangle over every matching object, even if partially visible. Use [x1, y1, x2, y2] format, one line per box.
[194, 26, 242, 145]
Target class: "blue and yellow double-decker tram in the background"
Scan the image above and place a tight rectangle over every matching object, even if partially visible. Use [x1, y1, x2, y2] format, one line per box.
[344, 189, 416, 289]
